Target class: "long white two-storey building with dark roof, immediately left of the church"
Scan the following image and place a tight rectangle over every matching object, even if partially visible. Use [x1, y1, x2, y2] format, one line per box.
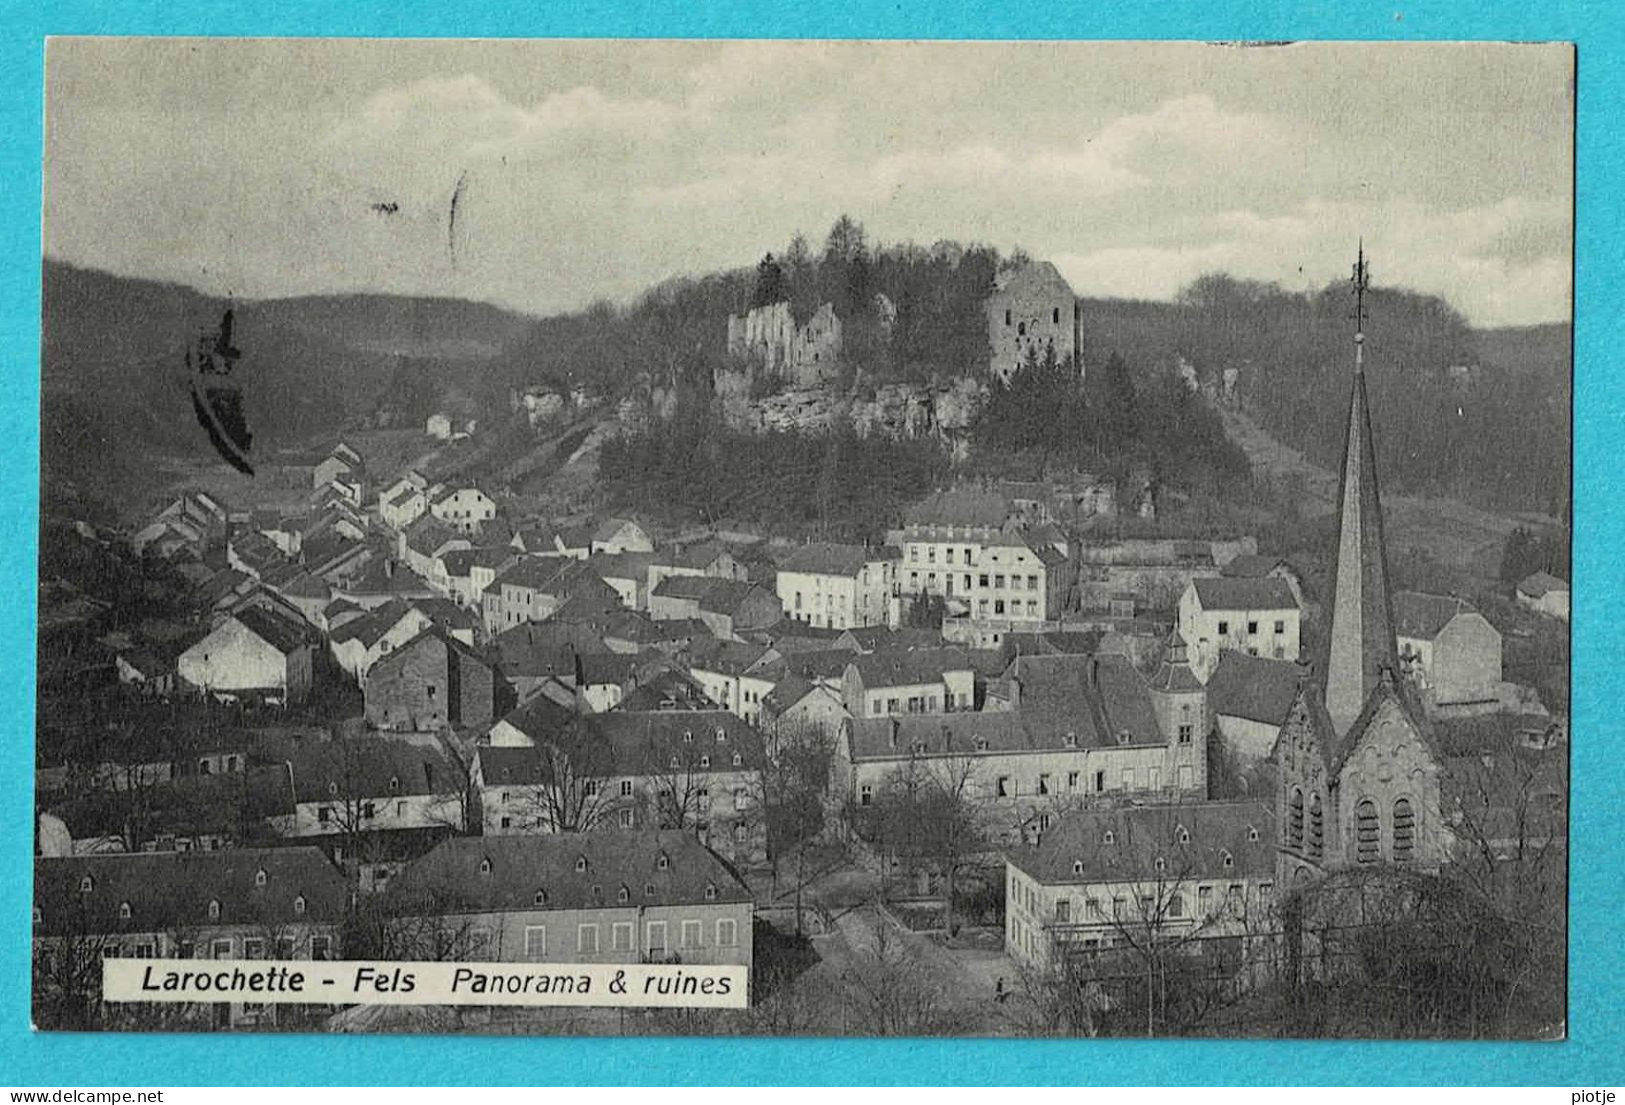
[1004, 801, 1279, 970]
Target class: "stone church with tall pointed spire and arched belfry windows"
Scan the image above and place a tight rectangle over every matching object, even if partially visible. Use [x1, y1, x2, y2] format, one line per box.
[1274, 249, 1450, 887]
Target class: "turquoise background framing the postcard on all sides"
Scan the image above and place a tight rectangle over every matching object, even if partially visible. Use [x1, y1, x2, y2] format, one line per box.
[0, 0, 1625, 1087]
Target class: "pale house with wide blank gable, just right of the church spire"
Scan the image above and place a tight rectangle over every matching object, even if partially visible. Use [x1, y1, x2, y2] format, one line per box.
[1394, 592, 1502, 704]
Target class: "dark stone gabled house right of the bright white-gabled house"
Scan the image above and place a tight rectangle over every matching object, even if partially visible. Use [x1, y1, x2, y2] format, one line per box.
[366, 626, 515, 731]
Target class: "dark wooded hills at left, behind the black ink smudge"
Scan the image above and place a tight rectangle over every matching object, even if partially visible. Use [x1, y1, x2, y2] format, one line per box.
[41, 260, 531, 510]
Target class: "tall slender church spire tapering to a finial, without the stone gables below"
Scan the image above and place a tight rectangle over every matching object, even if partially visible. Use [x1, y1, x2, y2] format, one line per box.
[1321, 242, 1398, 736]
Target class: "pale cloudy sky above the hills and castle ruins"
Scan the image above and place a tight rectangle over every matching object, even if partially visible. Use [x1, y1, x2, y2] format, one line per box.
[44, 39, 1573, 327]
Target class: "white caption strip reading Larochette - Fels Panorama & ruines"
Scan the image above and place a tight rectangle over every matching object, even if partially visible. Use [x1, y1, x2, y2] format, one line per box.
[102, 959, 749, 1009]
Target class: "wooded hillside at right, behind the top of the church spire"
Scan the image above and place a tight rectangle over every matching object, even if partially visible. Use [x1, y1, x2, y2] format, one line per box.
[1081, 276, 1571, 514]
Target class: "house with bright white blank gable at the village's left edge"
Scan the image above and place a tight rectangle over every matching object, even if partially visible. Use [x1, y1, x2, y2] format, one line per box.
[176, 608, 312, 705]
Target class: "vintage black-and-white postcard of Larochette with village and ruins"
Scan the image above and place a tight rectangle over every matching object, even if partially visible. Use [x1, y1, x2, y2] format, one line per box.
[33, 37, 1575, 1040]
